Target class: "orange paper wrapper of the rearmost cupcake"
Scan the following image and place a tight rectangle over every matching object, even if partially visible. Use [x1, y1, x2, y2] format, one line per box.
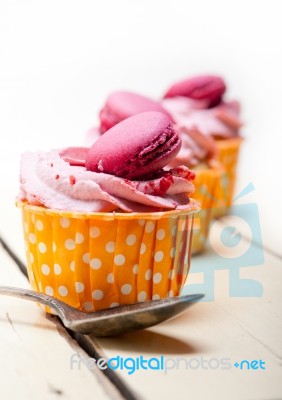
[212, 138, 243, 218]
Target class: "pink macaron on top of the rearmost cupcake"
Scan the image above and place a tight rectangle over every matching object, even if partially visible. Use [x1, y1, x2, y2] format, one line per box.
[164, 75, 226, 107]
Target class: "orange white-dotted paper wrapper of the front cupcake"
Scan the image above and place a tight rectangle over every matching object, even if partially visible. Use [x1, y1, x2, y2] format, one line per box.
[19, 203, 197, 311]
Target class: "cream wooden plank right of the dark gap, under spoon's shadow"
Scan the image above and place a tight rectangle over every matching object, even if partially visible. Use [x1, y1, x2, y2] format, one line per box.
[87, 224, 282, 400]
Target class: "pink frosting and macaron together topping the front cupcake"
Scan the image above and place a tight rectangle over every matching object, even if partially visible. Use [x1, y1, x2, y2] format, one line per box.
[19, 112, 195, 212]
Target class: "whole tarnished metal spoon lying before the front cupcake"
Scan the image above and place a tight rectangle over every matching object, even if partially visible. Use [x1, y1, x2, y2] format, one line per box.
[0, 285, 204, 336]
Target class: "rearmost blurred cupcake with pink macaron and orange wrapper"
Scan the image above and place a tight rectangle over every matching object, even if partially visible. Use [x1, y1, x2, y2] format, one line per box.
[162, 75, 242, 217]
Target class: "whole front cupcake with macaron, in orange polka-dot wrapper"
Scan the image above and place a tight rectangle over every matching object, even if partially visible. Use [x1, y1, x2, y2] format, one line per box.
[17, 112, 199, 311]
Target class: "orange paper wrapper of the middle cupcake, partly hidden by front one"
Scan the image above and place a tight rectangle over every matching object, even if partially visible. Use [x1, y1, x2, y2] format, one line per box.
[192, 168, 222, 254]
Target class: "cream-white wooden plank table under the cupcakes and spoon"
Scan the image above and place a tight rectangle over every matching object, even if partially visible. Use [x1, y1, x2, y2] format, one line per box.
[0, 130, 282, 400]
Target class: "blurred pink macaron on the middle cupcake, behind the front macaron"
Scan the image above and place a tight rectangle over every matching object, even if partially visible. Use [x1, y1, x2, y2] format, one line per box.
[99, 91, 172, 133]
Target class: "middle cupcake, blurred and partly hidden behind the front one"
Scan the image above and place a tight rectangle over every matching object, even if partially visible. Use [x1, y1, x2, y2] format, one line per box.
[87, 91, 222, 254]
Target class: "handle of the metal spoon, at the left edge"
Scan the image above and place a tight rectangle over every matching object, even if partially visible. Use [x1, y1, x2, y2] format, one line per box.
[0, 285, 66, 318]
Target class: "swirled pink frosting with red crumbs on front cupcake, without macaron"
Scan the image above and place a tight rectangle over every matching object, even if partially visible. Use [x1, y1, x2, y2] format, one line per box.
[19, 147, 195, 212]
